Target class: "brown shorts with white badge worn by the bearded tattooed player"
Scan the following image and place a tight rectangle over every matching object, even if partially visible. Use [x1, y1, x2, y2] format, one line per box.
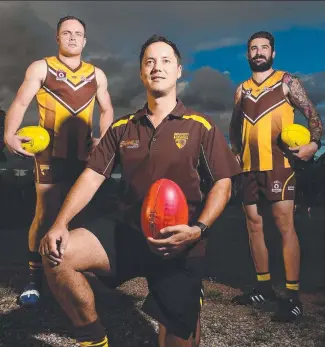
[241, 168, 296, 204]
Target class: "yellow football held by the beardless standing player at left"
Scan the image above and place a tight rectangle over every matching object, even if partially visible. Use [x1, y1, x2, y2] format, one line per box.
[17, 125, 50, 154]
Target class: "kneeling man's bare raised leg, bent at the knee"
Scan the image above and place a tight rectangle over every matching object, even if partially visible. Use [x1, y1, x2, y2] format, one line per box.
[43, 229, 110, 327]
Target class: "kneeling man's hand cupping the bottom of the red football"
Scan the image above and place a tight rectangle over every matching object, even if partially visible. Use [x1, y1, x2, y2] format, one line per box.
[147, 225, 201, 258]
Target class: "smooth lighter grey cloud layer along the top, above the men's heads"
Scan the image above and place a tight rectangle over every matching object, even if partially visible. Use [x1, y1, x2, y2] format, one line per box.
[29, 1, 325, 54]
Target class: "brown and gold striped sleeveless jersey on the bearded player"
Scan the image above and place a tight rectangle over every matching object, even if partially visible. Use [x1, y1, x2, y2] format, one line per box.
[241, 71, 294, 171]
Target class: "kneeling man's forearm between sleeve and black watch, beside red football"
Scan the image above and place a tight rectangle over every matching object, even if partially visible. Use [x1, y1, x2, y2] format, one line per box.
[198, 178, 231, 226]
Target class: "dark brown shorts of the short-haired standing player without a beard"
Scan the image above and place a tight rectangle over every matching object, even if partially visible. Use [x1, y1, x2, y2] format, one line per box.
[34, 155, 86, 184]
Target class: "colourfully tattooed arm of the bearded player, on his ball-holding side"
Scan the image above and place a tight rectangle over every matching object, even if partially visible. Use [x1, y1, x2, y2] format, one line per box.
[283, 73, 323, 140]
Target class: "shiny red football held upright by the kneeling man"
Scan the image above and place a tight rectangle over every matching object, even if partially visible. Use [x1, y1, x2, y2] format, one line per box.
[141, 178, 188, 238]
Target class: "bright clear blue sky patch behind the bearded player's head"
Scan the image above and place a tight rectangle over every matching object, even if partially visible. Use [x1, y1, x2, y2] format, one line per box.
[187, 26, 325, 84]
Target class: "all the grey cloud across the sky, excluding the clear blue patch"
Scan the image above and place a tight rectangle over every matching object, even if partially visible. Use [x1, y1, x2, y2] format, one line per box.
[0, 1, 325, 136]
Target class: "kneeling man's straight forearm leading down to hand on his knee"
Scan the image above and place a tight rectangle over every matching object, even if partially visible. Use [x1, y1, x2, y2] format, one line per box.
[54, 168, 105, 226]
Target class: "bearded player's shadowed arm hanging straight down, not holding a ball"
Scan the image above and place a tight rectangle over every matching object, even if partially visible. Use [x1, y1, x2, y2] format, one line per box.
[229, 86, 242, 155]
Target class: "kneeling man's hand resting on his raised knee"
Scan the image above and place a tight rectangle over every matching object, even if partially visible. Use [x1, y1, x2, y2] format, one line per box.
[39, 225, 69, 266]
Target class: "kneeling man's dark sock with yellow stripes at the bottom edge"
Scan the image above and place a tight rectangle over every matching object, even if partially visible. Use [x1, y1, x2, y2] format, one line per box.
[75, 318, 109, 347]
